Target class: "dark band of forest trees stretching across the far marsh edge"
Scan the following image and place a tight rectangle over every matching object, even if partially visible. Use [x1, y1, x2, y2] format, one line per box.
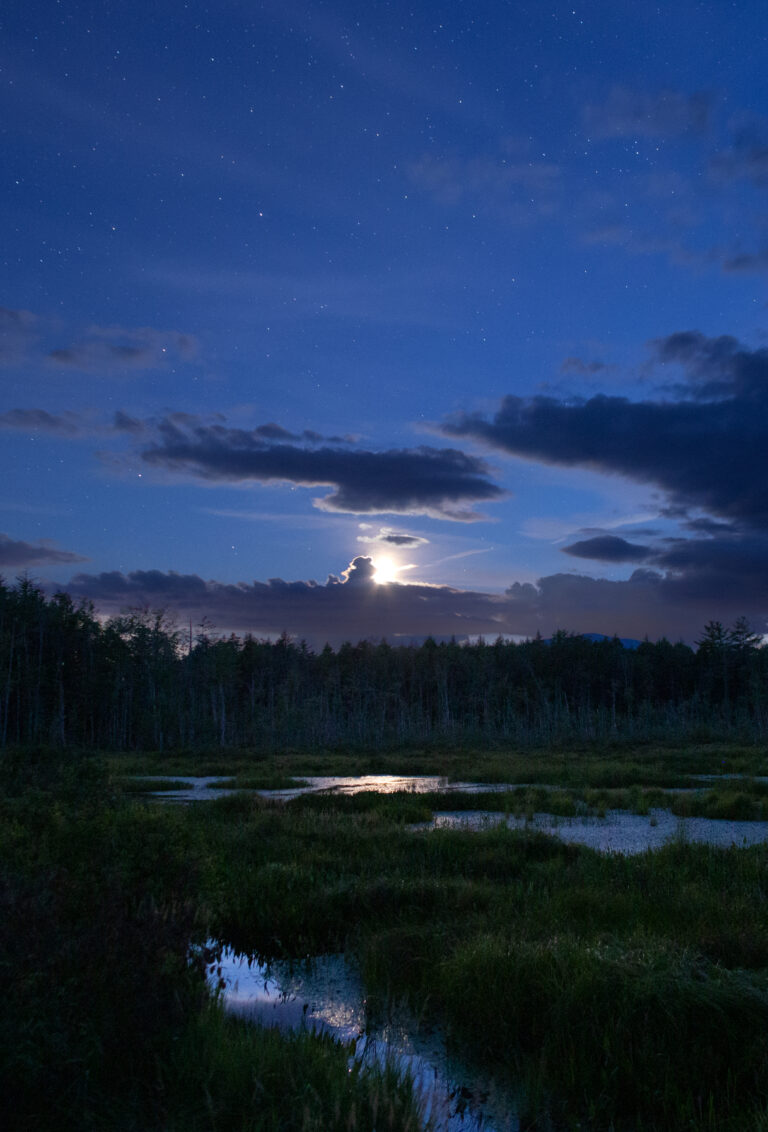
[0, 577, 768, 751]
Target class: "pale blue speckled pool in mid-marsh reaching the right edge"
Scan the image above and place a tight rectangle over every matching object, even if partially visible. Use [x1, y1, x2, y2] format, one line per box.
[419, 809, 768, 854]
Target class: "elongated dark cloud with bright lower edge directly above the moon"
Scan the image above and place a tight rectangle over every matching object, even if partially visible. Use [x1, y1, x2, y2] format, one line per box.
[142, 419, 503, 522]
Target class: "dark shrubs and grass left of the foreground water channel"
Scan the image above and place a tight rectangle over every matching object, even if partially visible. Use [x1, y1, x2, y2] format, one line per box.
[0, 753, 421, 1132]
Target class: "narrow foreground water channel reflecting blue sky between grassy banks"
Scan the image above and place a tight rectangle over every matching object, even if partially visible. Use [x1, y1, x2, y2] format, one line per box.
[210, 950, 520, 1132]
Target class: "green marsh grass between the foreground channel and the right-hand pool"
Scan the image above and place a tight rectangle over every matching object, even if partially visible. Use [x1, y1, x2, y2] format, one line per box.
[189, 796, 768, 1130]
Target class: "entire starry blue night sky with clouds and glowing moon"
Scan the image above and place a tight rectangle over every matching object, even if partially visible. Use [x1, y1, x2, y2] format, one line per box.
[0, 0, 768, 648]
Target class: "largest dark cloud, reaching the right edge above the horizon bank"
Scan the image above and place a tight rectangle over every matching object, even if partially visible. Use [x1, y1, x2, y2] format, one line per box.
[442, 331, 768, 528]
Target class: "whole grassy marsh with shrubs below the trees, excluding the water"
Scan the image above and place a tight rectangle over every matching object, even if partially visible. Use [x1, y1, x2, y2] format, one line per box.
[7, 747, 768, 1132]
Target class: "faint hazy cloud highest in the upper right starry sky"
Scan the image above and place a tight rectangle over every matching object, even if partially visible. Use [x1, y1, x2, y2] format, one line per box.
[584, 86, 711, 138]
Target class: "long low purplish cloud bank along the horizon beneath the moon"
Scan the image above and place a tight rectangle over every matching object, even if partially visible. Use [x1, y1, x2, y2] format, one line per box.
[62, 557, 768, 648]
